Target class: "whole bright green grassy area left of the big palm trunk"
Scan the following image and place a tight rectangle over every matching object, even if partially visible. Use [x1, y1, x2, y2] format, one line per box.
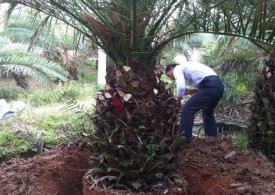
[0, 84, 97, 161]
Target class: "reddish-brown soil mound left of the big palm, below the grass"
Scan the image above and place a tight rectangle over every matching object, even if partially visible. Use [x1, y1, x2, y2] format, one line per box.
[0, 142, 91, 195]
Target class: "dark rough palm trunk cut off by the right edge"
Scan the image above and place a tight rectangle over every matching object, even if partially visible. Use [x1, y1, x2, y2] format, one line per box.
[249, 51, 275, 160]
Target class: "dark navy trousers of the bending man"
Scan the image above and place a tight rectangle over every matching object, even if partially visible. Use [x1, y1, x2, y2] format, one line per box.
[178, 76, 224, 143]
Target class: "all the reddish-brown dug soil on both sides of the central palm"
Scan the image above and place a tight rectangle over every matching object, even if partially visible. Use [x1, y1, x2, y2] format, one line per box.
[0, 138, 275, 195]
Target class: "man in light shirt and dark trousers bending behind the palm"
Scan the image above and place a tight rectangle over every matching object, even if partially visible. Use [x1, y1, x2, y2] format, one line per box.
[165, 62, 224, 143]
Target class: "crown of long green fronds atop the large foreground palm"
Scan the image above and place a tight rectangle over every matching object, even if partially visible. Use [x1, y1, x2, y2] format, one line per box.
[2, 0, 275, 67]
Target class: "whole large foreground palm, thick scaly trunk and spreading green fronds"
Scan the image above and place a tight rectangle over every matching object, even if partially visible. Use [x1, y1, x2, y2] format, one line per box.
[2, 0, 275, 190]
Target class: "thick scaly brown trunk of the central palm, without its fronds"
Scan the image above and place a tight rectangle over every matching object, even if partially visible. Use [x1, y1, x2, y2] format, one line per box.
[85, 66, 183, 191]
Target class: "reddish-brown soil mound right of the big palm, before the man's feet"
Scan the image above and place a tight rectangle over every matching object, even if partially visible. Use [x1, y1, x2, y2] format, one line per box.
[182, 138, 275, 195]
